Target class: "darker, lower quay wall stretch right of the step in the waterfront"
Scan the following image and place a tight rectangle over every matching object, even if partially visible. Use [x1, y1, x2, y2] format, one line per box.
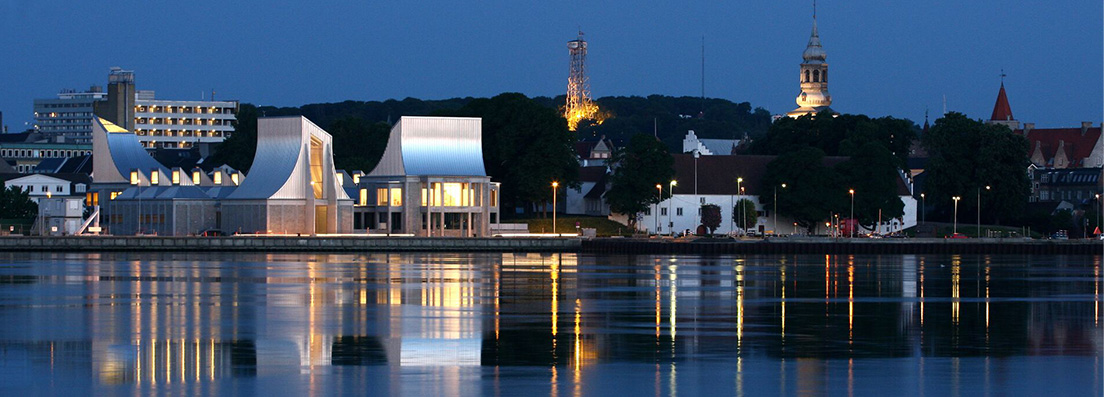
[582, 238, 1104, 255]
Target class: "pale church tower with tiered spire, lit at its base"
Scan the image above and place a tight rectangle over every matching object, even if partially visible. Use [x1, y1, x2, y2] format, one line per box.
[786, 1, 831, 118]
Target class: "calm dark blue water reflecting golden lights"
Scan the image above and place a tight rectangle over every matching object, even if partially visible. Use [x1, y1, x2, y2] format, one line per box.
[0, 254, 1104, 396]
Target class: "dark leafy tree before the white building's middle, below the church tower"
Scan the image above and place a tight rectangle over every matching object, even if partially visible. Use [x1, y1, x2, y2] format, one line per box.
[763, 147, 850, 232]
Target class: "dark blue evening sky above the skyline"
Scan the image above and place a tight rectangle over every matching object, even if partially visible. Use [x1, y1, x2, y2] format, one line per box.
[0, 0, 1104, 130]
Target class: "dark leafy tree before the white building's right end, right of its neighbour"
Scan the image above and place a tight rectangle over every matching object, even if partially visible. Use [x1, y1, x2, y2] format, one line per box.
[836, 141, 904, 226]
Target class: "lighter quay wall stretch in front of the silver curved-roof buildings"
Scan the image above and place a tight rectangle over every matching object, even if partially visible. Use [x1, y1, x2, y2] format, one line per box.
[0, 236, 581, 253]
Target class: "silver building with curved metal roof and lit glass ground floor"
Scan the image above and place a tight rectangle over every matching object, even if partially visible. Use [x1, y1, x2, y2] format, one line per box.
[352, 116, 499, 237]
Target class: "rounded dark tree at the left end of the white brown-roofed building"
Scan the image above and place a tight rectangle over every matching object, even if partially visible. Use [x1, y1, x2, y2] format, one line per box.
[606, 133, 675, 228]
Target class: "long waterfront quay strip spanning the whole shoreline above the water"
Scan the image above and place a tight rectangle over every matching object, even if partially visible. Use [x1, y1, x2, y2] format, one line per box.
[0, 236, 1104, 255]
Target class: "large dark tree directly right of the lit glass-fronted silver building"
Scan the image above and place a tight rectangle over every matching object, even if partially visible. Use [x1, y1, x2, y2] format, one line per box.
[459, 93, 578, 217]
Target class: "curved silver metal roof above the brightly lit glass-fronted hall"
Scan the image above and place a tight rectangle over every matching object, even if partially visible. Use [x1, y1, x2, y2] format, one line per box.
[369, 116, 487, 176]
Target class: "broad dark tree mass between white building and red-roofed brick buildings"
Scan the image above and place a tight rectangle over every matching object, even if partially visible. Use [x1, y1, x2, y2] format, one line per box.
[923, 112, 1030, 223]
